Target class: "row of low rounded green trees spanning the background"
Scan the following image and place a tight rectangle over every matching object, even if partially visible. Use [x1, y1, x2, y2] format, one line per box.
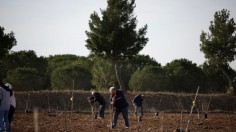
[1, 50, 236, 93]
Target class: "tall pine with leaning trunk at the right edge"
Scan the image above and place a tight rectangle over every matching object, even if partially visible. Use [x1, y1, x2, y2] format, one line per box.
[200, 9, 236, 87]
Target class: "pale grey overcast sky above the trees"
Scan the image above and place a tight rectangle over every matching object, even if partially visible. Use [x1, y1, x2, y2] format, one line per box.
[0, 0, 236, 69]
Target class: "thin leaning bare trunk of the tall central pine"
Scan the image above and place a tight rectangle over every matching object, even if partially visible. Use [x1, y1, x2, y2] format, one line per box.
[113, 60, 126, 92]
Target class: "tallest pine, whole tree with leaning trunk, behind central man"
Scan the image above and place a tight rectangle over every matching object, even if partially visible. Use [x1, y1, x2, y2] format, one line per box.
[86, 0, 148, 90]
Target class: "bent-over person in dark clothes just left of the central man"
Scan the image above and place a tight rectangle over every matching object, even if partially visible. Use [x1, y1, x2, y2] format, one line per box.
[92, 91, 106, 119]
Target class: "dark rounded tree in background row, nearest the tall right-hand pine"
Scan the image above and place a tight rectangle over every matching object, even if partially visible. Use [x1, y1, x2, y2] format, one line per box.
[164, 59, 204, 92]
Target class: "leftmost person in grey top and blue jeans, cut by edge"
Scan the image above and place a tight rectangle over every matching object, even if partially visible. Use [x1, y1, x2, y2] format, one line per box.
[0, 81, 11, 132]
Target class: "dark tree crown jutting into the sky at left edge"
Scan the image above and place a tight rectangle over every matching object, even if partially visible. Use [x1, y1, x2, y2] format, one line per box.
[0, 26, 16, 59]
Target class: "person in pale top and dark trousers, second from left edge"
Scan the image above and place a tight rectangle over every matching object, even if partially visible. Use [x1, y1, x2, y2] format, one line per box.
[5, 83, 16, 129]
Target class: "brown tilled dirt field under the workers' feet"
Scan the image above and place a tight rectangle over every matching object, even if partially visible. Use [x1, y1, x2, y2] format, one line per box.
[11, 112, 236, 132]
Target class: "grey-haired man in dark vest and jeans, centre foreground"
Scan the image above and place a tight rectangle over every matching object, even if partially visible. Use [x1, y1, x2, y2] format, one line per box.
[109, 87, 129, 128]
